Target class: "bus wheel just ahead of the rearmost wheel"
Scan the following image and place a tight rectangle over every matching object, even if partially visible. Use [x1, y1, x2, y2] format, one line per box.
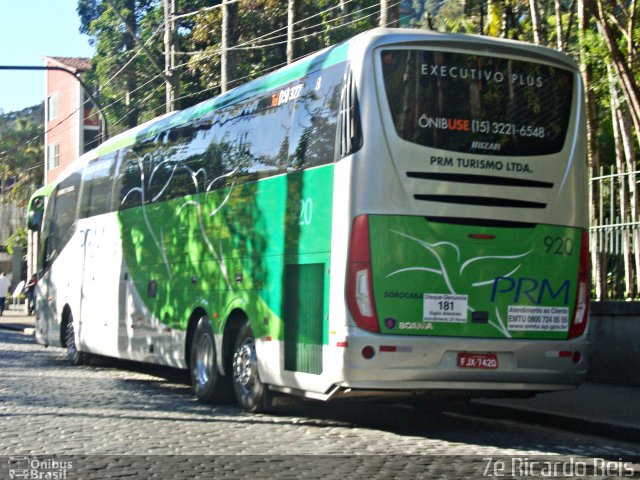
[189, 316, 221, 403]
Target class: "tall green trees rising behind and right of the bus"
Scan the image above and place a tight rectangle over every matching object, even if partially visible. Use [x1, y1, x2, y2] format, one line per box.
[78, 0, 640, 298]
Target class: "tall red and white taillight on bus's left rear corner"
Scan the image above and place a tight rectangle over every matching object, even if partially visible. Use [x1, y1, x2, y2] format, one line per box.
[347, 215, 380, 332]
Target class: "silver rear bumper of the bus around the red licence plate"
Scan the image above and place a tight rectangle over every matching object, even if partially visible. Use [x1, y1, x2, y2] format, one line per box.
[331, 334, 588, 392]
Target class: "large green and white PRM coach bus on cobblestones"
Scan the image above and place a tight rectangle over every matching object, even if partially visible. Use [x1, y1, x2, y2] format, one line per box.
[30, 29, 589, 411]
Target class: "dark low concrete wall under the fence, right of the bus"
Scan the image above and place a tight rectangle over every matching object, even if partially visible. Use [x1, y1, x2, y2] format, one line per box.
[587, 302, 640, 386]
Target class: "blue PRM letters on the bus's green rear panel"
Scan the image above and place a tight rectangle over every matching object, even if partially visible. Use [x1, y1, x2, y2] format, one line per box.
[491, 277, 571, 305]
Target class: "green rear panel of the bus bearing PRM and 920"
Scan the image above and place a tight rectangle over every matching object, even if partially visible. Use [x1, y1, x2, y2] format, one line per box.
[367, 215, 588, 340]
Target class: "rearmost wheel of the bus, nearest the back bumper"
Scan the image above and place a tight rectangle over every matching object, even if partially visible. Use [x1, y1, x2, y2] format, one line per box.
[231, 320, 273, 413]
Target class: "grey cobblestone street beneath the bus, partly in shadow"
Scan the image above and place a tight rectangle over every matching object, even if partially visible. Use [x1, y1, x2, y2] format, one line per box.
[0, 331, 640, 478]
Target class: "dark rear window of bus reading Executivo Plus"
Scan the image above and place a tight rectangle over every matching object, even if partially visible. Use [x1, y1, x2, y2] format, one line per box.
[381, 50, 574, 156]
